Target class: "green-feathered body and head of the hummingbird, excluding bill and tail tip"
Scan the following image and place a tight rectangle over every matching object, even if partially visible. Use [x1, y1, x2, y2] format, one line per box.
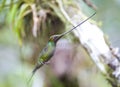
[33, 35, 59, 73]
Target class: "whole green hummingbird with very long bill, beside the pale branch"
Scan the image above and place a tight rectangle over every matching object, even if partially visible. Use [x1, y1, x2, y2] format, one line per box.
[29, 12, 96, 81]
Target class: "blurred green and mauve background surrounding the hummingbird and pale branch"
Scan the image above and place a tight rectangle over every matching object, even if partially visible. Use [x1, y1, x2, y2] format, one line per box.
[0, 0, 120, 87]
